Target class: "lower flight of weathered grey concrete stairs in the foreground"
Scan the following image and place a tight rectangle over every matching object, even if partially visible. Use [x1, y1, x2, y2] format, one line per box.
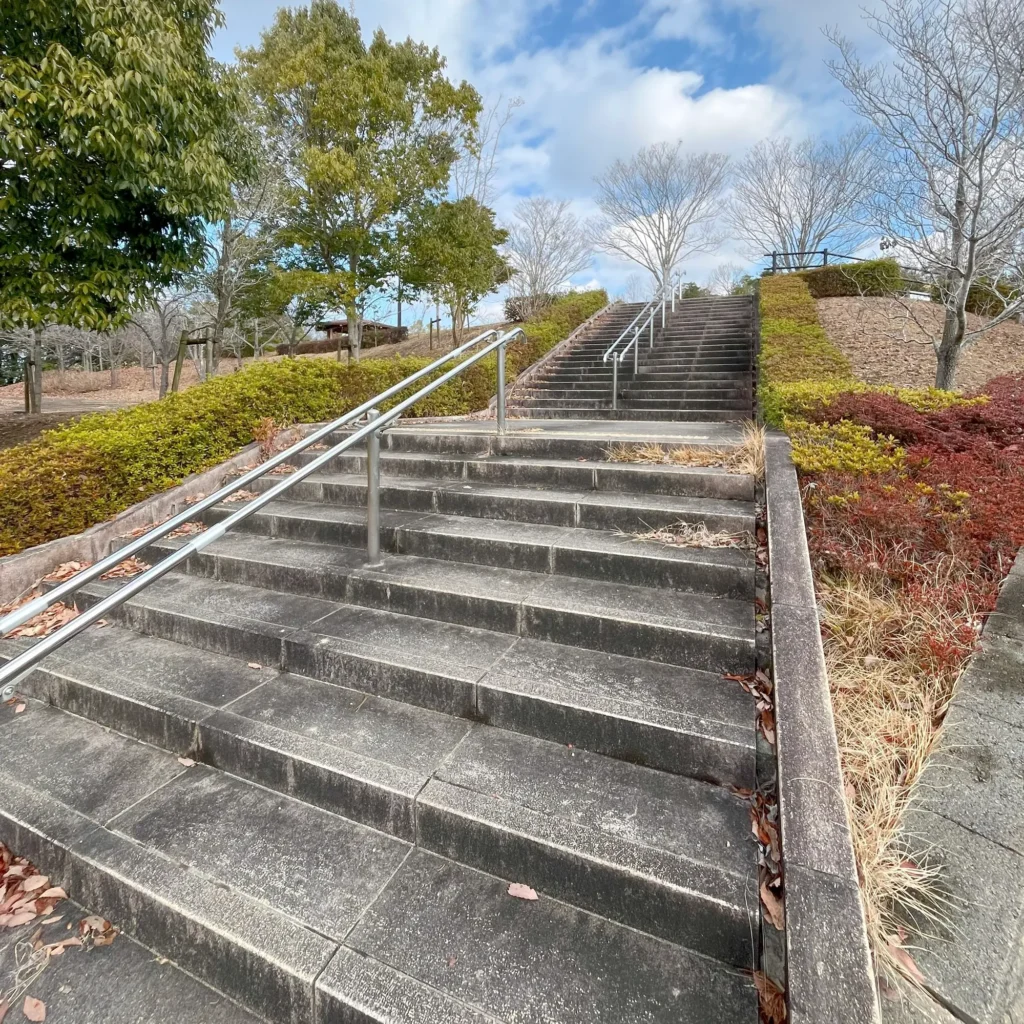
[0, 421, 759, 1024]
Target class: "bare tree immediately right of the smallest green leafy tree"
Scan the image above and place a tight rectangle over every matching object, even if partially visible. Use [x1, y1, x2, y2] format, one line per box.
[505, 196, 594, 316]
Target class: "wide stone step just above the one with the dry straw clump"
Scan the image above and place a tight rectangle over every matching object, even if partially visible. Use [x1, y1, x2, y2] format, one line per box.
[239, 468, 754, 535]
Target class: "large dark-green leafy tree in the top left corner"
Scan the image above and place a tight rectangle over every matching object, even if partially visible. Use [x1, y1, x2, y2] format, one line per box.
[0, 0, 234, 411]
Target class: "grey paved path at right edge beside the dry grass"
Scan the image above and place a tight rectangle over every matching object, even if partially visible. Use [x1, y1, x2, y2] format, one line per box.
[897, 549, 1024, 1024]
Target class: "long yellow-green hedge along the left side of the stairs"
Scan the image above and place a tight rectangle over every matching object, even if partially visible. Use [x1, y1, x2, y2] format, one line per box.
[0, 292, 607, 555]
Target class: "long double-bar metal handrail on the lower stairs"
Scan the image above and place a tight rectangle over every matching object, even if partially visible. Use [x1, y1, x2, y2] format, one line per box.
[0, 327, 525, 699]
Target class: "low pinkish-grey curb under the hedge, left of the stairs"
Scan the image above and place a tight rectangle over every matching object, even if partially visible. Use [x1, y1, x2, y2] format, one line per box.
[0, 426, 312, 604]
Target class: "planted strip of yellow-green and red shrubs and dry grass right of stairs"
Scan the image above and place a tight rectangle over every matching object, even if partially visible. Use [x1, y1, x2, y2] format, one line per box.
[759, 271, 1024, 975]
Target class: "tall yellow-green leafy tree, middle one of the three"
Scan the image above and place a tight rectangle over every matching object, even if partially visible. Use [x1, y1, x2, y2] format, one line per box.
[239, 0, 480, 358]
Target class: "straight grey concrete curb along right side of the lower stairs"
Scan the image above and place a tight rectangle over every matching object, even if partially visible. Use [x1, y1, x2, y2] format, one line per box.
[765, 431, 882, 1024]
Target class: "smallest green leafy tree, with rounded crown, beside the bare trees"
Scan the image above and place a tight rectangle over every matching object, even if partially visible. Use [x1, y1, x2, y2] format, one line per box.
[409, 199, 512, 344]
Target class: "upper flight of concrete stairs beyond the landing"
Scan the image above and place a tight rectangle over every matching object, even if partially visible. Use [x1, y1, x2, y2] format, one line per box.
[510, 296, 754, 421]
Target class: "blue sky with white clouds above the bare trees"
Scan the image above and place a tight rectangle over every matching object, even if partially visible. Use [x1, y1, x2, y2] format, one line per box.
[205, 0, 872, 317]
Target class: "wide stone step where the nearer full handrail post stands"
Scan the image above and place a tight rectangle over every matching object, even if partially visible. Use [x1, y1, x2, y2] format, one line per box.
[147, 535, 754, 673]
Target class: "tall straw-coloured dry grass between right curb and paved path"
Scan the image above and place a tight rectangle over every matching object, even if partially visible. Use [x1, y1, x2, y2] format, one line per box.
[818, 559, 982, 983]
